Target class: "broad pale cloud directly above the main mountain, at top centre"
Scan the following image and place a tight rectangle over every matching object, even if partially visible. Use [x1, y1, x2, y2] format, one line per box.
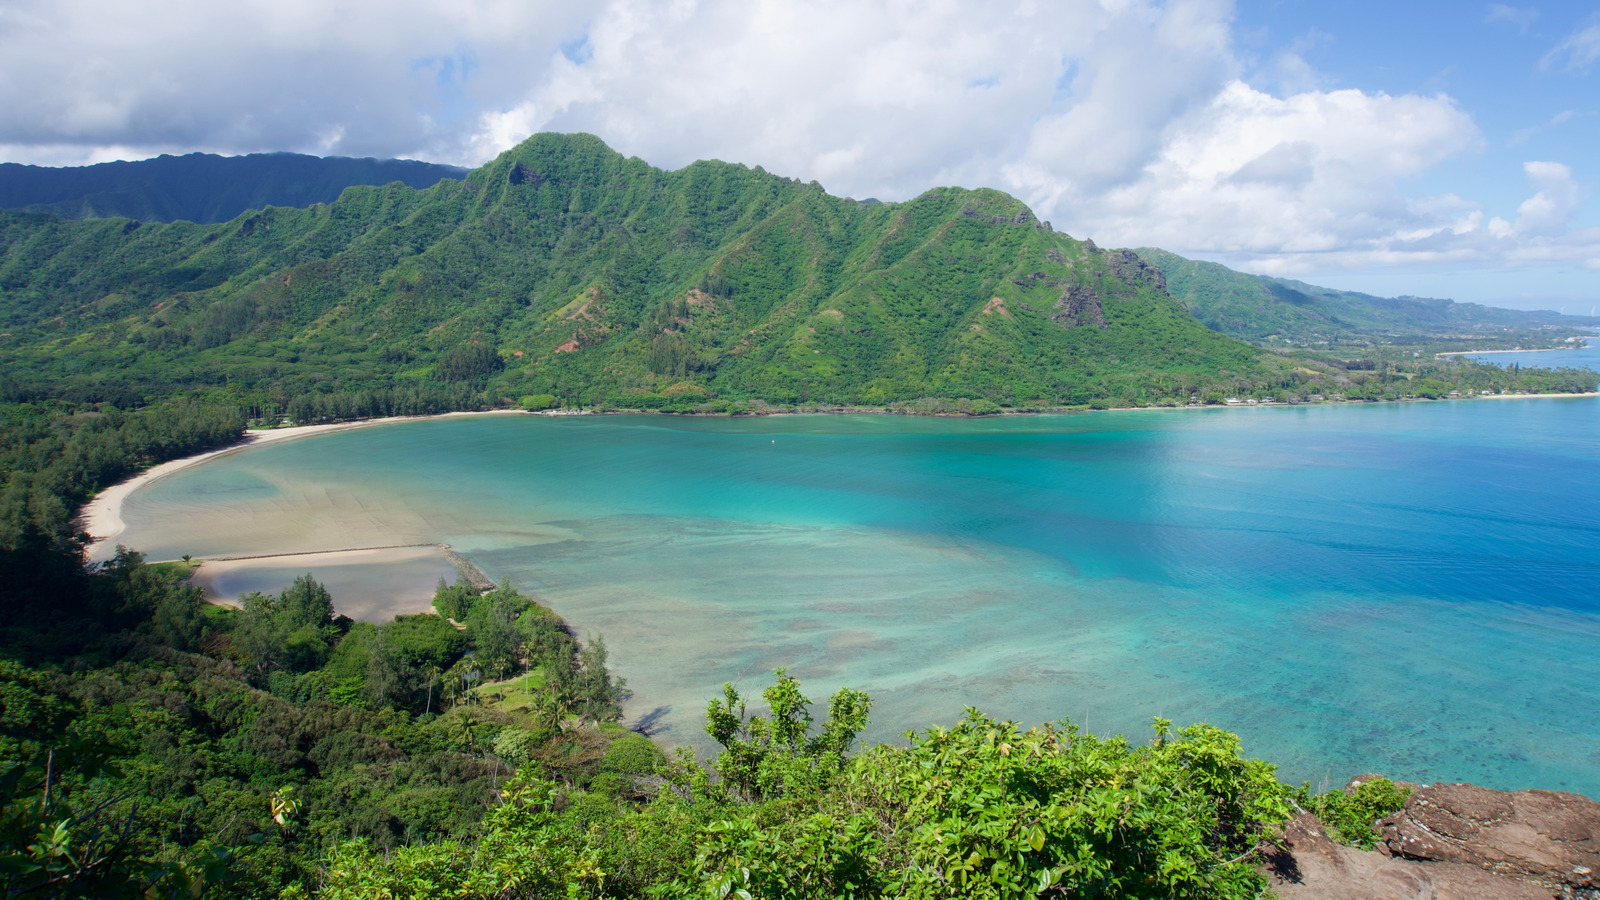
[486, 0, 1113, 197]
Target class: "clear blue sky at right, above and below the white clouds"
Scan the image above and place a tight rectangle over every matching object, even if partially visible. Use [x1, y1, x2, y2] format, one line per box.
[1235, 0, 1600, 304]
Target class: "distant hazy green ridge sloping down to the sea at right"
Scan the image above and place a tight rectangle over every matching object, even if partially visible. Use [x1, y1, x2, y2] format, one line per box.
[1136, 247, 1600, 351]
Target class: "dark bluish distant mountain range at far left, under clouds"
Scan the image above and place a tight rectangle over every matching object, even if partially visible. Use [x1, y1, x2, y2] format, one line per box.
[0, 154, 467, 223]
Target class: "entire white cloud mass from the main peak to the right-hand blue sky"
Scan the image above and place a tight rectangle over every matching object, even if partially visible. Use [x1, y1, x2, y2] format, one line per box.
[460, 0, 1579, 269]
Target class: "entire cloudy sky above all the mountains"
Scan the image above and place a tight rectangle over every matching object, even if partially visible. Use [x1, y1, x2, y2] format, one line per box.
[0, 0, 1600, 307]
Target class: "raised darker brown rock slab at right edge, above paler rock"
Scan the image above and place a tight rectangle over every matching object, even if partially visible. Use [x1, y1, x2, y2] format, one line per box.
[1379, 785, 1600, 897]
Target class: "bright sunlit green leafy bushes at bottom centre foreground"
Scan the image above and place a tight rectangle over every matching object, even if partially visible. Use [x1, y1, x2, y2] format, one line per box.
[308, 673, 1288, 900]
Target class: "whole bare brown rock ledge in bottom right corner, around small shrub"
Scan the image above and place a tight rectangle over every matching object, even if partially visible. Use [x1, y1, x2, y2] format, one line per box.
[1269, 775, 1600, 900]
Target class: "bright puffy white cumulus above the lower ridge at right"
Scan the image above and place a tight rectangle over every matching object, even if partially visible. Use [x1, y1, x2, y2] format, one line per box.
[1017, 82, 1480, 255]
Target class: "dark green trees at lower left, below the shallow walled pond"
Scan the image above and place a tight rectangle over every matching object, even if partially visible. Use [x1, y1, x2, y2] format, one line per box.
[0, 552, 636, 897]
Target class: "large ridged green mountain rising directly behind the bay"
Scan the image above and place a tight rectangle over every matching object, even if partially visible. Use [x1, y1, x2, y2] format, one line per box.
[0, 135, 1302, 408]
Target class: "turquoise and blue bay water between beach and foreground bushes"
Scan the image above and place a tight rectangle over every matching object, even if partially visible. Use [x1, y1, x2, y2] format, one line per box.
[122, 399, 1600, 796]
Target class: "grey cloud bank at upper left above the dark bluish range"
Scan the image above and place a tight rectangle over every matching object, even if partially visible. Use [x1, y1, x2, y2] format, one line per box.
[0, 0, 582, 162]
